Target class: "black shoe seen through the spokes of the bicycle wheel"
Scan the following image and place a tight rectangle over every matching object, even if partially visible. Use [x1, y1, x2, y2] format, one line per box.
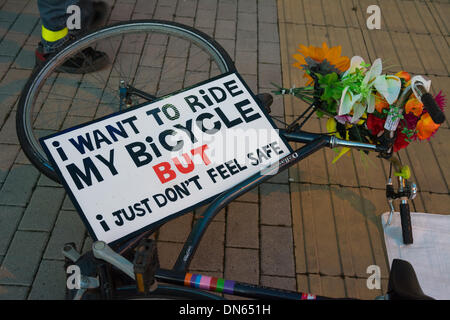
[35, 43, 109, 74]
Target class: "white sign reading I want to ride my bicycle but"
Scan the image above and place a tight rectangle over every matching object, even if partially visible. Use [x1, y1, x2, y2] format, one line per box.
[41, 73, 291, 243]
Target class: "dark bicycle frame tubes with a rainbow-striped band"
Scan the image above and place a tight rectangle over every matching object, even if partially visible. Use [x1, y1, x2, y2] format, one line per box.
[85, 130, 385, 300]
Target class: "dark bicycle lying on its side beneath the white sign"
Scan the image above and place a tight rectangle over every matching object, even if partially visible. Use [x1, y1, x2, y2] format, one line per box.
[17, 20, 437, 299]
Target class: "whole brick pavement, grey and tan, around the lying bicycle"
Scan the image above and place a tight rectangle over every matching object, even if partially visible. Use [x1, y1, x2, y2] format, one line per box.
[0, 0, 450, 299]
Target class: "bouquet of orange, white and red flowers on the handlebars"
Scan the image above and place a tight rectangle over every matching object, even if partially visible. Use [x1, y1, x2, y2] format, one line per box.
[274, 43, 446, 162]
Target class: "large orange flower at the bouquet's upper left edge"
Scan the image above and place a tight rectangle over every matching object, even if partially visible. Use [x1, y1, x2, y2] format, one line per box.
[293, 42, 350, 85]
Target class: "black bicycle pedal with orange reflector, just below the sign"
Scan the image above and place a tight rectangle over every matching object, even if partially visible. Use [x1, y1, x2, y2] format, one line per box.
[133, 239, 159, 295]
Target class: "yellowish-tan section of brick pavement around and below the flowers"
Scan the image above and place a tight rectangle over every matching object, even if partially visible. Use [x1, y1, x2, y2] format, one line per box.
[278, 0, 450, 298]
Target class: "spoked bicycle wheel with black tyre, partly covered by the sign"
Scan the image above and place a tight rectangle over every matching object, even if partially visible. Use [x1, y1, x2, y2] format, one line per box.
[16, 20, 235, 182]
